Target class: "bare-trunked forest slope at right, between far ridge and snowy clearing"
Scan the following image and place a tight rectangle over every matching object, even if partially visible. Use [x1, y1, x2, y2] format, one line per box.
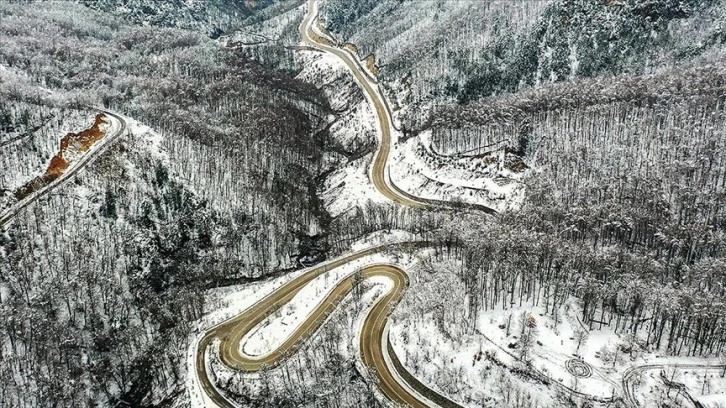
[412, 63, 726, 356]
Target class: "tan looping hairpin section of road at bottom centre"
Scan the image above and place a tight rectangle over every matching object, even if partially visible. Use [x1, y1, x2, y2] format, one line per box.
[197, 255, 458, 408]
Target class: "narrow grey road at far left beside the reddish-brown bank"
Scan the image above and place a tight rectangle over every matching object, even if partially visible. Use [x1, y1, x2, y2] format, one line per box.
[0, 109, 126, 227]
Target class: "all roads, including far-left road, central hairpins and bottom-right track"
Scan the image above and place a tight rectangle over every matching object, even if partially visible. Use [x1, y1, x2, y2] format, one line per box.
[0, 4, 724, 408]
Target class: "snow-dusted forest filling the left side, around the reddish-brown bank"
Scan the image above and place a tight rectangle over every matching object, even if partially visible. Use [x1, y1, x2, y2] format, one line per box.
[0, 3, 348, 407]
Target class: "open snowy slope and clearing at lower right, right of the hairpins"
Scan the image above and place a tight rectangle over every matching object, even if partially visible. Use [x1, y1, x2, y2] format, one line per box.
[390, 259, 726, 407]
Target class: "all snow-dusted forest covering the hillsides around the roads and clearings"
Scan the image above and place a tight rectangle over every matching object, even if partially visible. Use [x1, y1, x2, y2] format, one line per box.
[0, 0, 726, 407]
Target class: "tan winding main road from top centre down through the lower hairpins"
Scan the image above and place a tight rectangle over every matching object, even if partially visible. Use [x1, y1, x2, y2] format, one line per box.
[196, 0, 496, 407]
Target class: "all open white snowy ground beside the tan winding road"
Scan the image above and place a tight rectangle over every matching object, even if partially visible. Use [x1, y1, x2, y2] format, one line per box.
[188, 4, 724, 407]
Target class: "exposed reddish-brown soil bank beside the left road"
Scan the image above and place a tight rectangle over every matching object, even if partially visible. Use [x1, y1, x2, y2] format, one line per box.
[15, 113, 108, 200]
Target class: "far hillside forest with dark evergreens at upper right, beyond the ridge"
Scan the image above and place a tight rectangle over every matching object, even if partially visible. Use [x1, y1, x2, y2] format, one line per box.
[323, 0, 726, 111]
